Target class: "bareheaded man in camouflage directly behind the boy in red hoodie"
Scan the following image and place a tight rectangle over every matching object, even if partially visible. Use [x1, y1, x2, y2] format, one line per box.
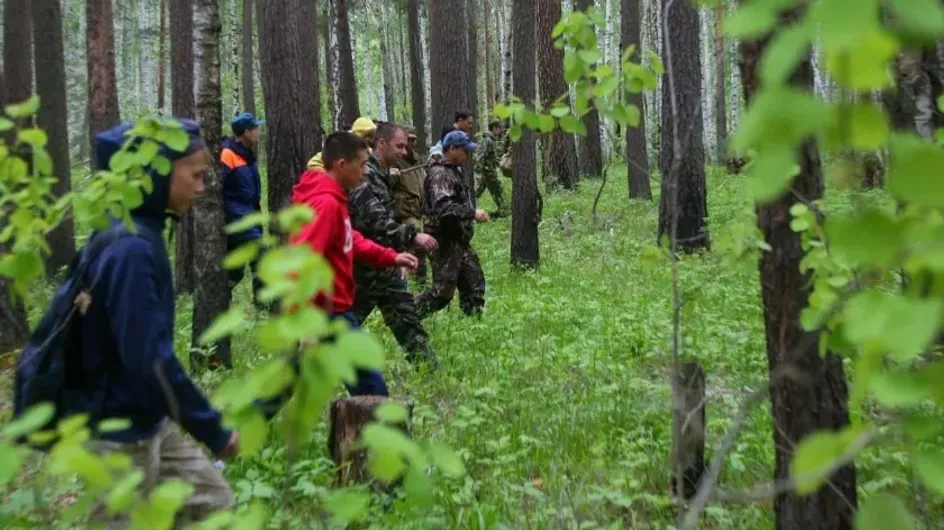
[348, 123, 437, 367]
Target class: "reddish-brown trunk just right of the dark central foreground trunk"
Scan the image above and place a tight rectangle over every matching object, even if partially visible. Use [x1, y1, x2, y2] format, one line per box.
[537, 0, 577, 190]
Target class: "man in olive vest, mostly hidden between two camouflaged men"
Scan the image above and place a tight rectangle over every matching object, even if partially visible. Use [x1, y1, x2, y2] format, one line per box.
[390, 127, 426, 286]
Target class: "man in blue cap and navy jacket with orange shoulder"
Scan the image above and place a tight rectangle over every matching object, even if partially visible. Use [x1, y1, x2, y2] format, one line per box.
[220, 112, 265, 307]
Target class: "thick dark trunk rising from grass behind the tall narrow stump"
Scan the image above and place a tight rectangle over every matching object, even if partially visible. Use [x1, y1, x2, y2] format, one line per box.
[659, 0, 710, 252]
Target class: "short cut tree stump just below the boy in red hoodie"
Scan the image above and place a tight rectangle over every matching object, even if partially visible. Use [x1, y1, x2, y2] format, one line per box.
[328, 396, 413, 485]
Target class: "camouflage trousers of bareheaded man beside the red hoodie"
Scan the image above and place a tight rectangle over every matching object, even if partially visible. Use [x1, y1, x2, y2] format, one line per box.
[351, 266, 436, 362]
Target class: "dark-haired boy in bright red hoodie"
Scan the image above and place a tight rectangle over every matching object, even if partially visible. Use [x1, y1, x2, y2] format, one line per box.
[292, 132, 419, 396]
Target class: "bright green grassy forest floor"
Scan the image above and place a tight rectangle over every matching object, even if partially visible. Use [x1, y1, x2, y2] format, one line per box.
[0, 168, 944, 530]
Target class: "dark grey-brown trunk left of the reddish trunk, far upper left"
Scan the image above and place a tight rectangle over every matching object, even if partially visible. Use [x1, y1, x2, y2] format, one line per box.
[27, 0, 75, 272]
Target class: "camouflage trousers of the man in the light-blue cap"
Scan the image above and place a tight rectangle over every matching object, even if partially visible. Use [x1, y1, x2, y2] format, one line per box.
[416, 242, 485, 318]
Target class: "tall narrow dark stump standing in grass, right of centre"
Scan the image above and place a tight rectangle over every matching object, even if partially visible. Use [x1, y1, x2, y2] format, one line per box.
[672, 362, 705, 499]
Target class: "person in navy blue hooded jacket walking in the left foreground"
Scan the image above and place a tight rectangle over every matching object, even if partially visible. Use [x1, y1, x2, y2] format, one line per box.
[80, 120, 239, 528]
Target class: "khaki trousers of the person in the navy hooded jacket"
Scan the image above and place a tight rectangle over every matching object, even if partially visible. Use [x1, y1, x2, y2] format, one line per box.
[91, 420, 235, 530]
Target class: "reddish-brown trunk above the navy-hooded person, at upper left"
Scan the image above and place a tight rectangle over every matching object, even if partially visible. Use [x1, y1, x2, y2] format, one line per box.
[85, 0, 121, 152]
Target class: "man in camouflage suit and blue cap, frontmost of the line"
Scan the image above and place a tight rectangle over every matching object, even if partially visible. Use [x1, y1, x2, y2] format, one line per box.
[416, 131, 488, 318]
